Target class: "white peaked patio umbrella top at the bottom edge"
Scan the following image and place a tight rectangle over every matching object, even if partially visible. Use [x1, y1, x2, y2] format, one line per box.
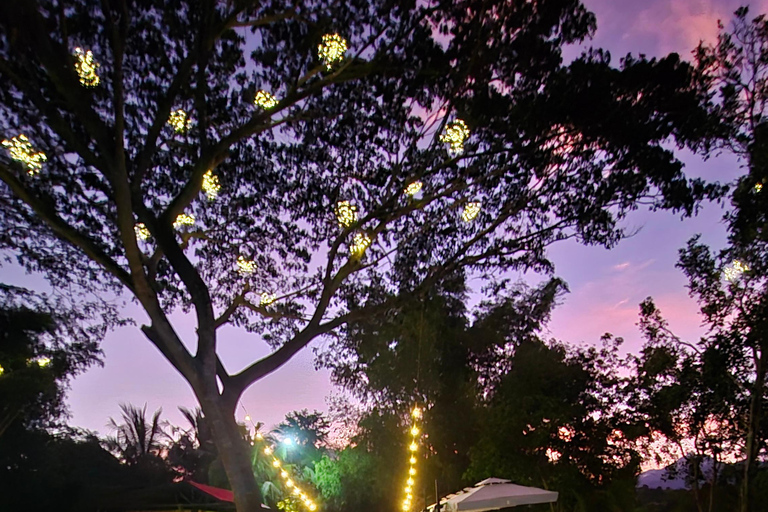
[429, 478, 557, 512]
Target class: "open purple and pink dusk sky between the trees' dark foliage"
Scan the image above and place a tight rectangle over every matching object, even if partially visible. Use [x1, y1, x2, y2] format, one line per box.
[3, 0, 768, 434]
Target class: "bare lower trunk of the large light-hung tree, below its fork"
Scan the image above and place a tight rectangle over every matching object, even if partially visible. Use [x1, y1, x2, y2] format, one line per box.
[198, 393, 262, 512]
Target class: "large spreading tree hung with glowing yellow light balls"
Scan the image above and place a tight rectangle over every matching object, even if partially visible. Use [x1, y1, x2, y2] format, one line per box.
[0, 0, 724, 511]
